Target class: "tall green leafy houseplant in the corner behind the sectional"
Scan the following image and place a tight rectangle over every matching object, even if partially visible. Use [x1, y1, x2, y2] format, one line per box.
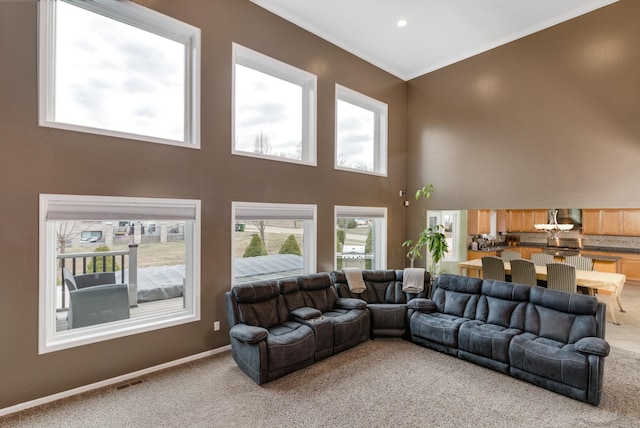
[402, 184, 449, 277]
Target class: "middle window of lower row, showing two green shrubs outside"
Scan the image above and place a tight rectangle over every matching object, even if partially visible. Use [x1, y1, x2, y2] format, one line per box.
[232, 202, 316, 284]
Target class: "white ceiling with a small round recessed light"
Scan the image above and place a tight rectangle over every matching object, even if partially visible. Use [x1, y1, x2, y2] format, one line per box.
[251, 0, 618, 80]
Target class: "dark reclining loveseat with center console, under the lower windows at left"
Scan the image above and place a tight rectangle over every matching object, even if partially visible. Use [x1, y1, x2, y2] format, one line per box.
[225, 273, 369, 384]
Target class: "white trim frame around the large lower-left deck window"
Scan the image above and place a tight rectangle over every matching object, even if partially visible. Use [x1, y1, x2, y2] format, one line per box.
[38, 194, 201, 354]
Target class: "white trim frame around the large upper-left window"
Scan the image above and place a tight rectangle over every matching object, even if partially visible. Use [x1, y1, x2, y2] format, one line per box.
[38, 0, 200, 149]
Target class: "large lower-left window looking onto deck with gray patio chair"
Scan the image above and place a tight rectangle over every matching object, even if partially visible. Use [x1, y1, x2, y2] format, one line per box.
[39, 195, 200, 353]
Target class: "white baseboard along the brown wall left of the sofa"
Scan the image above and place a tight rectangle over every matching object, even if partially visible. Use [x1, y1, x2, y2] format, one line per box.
[0, 345, 231, 416]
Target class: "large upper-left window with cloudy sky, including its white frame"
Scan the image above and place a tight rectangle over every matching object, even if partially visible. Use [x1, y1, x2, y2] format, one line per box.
[38, 0, 200, 148]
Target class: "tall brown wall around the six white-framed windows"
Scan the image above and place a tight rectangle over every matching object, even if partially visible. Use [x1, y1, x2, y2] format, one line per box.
[0, 0, 406, 409]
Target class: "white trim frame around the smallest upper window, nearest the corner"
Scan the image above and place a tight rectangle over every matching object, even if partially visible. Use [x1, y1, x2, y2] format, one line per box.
[334, 84, 388, 177]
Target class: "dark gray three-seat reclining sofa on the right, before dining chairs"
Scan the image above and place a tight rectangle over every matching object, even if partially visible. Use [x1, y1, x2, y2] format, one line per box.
[409, 274, 609, 406]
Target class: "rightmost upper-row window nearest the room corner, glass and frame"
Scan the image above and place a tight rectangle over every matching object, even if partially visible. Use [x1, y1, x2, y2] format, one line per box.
[336, 85, 387, 176]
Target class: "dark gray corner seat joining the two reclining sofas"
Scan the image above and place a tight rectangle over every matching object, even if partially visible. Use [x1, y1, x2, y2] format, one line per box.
[331, 269, 431, 338]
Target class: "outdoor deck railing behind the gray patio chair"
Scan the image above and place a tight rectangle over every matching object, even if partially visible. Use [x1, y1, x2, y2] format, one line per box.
[56, 244, 138, 310]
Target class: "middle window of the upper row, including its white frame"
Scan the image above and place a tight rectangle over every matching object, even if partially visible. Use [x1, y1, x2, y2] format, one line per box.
[232, 43, 317, 165]
